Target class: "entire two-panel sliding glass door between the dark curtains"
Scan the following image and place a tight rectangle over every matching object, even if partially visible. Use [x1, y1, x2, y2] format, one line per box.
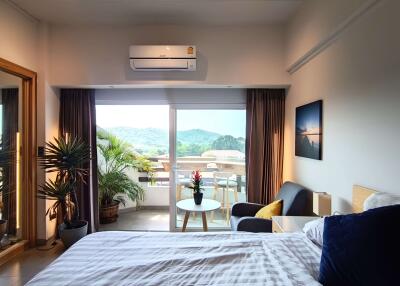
[96, 101, 247, 231]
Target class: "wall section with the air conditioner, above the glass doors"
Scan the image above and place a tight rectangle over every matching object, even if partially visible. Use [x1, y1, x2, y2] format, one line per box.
[50, 25, 289, 86]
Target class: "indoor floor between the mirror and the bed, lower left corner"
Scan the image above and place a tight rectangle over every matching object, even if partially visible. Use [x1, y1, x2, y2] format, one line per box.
[0, 242, 64, 286]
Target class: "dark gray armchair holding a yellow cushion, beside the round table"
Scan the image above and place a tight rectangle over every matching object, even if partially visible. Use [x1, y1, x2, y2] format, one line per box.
[231, 182, 314, 232]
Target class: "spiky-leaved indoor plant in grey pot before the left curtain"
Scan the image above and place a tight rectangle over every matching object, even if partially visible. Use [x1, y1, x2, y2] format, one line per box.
[38, 137, 91, 248]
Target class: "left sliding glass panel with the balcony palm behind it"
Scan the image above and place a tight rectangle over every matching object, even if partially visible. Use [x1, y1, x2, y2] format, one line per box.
[96, 104, 170, 231]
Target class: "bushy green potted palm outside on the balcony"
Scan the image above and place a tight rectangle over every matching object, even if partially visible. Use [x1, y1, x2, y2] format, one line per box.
[97, 130, 152, 224]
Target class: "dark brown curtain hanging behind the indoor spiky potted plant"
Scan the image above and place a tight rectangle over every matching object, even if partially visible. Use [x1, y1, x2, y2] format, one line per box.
[59, 89, 99, 233]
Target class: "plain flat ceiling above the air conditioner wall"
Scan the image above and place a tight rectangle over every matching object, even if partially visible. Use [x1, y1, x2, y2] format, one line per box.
[8, 0, 302, 25]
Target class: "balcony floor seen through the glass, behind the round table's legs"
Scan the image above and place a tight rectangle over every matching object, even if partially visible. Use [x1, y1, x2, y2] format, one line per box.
[100, 210, 229, 231]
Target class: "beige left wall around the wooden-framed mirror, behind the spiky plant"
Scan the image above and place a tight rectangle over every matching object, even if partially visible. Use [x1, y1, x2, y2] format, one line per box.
[0, 0, 58, 239]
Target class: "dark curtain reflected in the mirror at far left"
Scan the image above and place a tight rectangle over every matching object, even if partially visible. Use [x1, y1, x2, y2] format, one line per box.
[1, 88, 18, 235]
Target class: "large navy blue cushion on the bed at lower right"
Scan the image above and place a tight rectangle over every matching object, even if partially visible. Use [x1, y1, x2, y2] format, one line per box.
[319, 205, 400, 286]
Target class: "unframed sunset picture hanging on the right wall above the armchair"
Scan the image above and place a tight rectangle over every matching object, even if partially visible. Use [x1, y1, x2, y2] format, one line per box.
[295, 100, 322, 160]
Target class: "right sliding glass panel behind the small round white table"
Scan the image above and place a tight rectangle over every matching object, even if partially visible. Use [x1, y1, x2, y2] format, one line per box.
[170, 106, 246, 230]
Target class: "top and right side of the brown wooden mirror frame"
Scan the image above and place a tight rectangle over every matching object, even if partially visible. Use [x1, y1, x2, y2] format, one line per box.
[0, 58, 37, 247]
